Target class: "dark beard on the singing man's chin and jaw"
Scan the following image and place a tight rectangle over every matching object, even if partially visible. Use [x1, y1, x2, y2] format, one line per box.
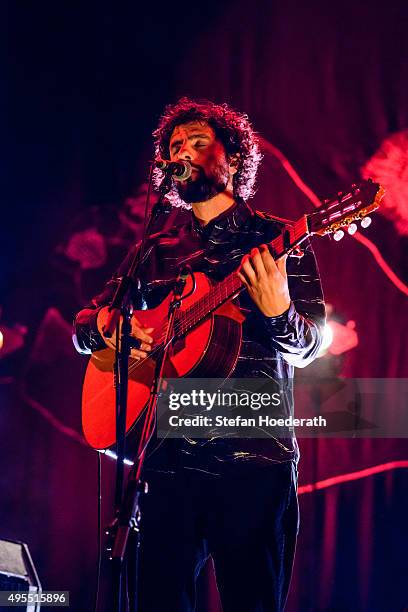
[176, 160, 229, 204]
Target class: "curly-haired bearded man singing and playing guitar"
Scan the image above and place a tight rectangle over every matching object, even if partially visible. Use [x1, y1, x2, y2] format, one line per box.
[74, 98, 325, 612]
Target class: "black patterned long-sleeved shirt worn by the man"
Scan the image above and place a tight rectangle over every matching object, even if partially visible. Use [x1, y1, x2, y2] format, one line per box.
[74, 201, 325, 472]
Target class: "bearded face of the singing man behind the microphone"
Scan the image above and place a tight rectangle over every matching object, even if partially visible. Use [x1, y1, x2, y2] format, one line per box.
[169, 121, 233, 204]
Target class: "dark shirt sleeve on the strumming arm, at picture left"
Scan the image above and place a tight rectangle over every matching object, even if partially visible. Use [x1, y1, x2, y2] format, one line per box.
[72, 239, 140, 355]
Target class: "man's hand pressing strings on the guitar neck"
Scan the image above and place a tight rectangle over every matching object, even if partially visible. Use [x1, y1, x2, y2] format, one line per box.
[238, 244, 290, 317]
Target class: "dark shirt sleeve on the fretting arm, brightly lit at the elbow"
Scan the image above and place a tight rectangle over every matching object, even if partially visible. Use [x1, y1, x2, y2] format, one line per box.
[263, 242, 326, 368]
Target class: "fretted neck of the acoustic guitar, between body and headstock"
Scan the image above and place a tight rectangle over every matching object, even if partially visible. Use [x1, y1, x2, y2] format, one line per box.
[177, 215, 310, 336]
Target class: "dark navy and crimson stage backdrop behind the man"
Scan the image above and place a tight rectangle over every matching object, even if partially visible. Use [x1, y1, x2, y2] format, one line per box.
[0, 0, 408, 612]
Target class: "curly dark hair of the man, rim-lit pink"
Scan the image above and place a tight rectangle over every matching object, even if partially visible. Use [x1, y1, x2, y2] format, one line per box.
[153, 97, 262, 208]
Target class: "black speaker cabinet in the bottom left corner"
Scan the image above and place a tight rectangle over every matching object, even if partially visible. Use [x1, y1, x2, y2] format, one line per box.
[0, 540, 41, 612]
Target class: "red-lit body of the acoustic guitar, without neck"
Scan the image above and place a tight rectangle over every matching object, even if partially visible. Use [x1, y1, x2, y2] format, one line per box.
[82, 272, 245, 450]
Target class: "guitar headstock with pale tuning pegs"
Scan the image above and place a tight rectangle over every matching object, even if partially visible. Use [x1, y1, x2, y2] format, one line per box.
[307, 179, 384, 240]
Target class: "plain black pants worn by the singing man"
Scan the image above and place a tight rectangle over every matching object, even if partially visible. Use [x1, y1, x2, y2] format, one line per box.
[130, 462, 299, 612]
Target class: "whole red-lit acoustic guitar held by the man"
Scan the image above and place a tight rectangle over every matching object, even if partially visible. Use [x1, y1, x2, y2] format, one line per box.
[82, 180, 384, 450]
